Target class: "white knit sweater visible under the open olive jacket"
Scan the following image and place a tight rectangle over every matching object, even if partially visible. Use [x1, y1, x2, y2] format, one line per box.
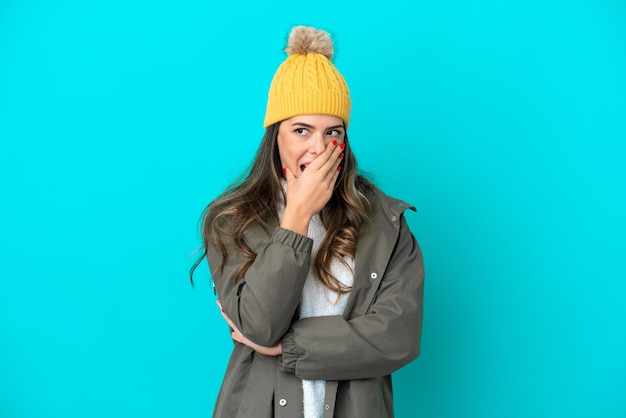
[278, 186, 354, 418]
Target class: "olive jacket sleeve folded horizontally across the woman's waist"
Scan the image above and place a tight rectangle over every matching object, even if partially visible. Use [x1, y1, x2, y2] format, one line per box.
[281, 217, 424, 380]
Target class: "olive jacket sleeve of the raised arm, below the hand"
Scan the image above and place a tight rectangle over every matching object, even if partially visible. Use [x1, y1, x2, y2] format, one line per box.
[207, 225, 313, 347]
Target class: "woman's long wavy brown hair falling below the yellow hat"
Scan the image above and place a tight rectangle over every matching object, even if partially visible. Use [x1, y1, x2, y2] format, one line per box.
[190, 122, 374, 294]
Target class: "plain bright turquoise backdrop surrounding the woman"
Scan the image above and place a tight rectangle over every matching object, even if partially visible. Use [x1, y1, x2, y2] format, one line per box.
[0, 0, 626, 418]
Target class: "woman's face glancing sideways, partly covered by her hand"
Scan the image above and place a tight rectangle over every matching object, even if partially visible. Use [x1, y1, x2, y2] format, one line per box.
[278, 115, 346, 177]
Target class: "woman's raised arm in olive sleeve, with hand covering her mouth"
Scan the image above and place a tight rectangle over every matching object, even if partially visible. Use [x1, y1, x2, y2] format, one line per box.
[207, 141, 343, 347]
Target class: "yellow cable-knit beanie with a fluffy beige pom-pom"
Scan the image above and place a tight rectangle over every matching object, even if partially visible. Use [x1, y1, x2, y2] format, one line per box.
[263, 26, 351, 128]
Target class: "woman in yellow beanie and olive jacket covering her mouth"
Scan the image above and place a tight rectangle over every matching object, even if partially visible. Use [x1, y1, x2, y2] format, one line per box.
[192, 26, 424, 418]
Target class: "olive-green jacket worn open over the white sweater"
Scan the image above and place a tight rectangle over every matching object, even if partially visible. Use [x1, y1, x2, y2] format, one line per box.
[207, 191, 424, 418]
